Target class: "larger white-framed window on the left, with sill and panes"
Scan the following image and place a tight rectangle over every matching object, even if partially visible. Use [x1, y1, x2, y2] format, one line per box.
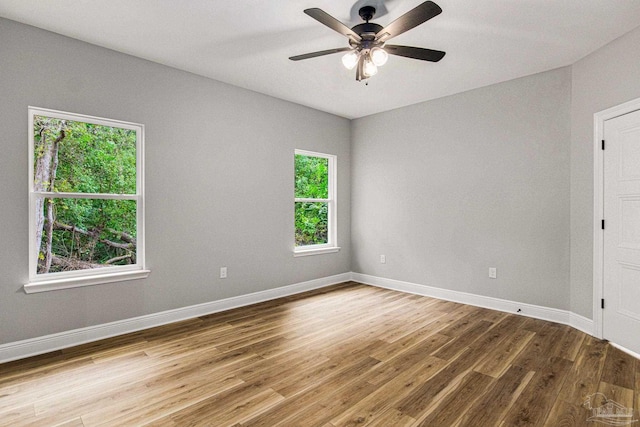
[25, 107, 149, 293]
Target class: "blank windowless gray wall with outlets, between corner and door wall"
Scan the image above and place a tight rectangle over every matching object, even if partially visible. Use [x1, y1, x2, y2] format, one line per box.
[351, 68, 571, 309]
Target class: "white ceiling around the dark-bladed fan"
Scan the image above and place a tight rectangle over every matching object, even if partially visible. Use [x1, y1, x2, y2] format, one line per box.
[0, 0, 640, 118]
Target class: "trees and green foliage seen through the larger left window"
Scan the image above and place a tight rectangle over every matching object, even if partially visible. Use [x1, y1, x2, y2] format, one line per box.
[33, 116, 137, 274]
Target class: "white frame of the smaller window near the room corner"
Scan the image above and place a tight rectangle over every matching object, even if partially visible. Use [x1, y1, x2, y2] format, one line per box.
[293, 149, 340, 257]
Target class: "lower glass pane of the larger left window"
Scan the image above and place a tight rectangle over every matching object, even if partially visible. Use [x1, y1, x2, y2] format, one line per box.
[36, 197, 137, 274]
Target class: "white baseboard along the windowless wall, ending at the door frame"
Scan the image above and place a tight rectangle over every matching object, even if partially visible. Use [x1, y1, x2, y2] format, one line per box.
[351, 273, 593, 335]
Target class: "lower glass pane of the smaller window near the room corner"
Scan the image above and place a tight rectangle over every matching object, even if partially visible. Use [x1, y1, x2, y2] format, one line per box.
[295, 202, 329, 246]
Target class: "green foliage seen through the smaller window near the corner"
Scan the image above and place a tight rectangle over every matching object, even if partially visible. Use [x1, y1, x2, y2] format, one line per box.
[295, 154, 329, 246]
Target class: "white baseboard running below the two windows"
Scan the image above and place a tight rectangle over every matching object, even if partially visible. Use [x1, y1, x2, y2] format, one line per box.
[0, 273, 351, 363]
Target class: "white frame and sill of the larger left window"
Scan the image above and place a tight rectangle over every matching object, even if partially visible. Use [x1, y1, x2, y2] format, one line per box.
[24, 107, 150, 293]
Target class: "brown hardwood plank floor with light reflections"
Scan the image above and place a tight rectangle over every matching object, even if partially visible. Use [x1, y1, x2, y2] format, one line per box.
[0, 283, 640, 427]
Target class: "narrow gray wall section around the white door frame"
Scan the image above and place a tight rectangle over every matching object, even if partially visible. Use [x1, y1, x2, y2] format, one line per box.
[571, 27, 640, 318]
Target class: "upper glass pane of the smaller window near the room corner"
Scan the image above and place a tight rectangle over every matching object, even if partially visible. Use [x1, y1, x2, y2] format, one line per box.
[295, 154, 329, 199]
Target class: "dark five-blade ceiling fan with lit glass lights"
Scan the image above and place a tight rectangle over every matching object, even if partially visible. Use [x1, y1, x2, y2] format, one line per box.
[289, 1, 445, 81]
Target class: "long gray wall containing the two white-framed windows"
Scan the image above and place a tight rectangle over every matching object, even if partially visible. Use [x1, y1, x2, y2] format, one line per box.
[0, 19, 351, 344]
